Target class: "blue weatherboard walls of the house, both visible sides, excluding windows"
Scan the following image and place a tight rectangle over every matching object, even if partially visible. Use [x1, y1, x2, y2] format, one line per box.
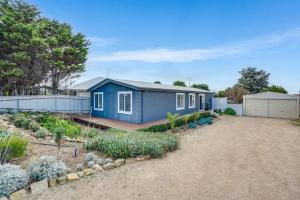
[91, 82, 213, 123]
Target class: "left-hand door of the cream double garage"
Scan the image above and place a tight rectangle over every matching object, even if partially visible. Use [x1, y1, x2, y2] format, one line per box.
[244, 99, 268, 117]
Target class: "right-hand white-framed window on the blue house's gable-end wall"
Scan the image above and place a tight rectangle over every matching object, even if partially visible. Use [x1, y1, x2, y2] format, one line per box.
[118, 91, 132, 115]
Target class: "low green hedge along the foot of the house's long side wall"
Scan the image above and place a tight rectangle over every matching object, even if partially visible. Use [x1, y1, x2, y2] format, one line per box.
[139, 112, 211, 132]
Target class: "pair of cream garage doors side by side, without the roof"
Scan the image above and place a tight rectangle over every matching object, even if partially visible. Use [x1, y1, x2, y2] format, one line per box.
[244, 99, 298, 119]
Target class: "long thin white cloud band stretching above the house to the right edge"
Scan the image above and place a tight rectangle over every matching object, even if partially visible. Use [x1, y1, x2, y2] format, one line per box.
[89, 28, 300, 63]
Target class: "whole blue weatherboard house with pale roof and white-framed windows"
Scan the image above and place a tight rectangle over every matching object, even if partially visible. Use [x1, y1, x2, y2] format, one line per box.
[71, 78, 213, 123]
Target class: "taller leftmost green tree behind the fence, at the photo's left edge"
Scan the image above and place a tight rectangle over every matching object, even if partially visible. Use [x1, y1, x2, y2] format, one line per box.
[0, 0, 46, 95]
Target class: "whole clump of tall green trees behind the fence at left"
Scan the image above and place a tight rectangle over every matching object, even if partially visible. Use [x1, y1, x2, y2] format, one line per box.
[0, 0, 89, 95]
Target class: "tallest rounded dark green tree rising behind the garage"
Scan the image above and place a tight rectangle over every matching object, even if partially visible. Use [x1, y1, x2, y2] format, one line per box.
[238, 67, 270, 94]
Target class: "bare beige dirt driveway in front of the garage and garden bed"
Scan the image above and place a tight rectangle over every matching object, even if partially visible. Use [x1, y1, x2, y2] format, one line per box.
[29, 117, 300, 200]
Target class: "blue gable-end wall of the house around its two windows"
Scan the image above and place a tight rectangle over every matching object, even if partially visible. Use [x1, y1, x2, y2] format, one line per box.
[91, 83, 142, 123]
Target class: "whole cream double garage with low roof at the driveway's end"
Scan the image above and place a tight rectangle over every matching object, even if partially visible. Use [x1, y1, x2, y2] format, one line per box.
[243, 92, 299, 119]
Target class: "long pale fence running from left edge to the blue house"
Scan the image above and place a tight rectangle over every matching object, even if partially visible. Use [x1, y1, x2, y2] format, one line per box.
[0, 95, 91, 113]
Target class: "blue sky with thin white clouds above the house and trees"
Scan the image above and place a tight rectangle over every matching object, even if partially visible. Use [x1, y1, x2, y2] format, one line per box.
[28, 0, 300, 93]
